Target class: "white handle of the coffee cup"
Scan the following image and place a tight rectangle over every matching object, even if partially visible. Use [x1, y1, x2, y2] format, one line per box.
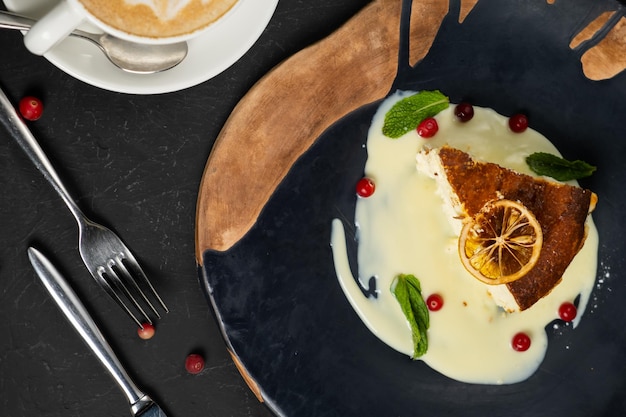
[24, 1, 86, 55]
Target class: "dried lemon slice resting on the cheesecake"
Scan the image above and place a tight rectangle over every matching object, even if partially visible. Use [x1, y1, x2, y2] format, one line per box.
[459, 199, 543, 285]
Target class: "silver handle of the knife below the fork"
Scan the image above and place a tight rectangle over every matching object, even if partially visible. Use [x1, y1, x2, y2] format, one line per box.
[28, 247, 152, 409]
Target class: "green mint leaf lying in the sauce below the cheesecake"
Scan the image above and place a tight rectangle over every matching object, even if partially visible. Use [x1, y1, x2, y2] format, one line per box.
[391, 274, 430, 359]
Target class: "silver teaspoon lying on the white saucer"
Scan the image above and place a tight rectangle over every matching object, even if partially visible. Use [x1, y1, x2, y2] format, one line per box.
[0, 10, 187, 74]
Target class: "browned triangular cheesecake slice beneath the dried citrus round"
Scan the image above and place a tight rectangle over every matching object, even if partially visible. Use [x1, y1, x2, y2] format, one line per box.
[417, 146, 597, 312]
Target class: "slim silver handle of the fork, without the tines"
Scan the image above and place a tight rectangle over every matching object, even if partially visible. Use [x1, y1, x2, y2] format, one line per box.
[0, 85, 85, 223]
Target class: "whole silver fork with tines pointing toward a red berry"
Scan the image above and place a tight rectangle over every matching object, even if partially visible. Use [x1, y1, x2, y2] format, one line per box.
[0, 89, 169, 328]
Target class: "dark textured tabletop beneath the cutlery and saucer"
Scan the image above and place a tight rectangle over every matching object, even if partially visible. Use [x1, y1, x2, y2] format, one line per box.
[0, 0, 368, 417]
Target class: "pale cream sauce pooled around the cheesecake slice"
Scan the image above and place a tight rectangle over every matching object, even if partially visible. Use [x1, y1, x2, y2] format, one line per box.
[331, 92, 598, 384]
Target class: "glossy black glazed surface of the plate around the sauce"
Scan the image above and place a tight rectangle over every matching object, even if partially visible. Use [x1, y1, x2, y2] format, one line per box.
[202, 0, 626, 417]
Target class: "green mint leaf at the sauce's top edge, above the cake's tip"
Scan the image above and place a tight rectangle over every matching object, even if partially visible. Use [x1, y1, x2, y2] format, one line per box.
[383, 90, 450, 139]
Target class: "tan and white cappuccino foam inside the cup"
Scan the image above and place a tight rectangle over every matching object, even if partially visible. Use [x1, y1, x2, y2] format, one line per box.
[80, 0, 238, 38]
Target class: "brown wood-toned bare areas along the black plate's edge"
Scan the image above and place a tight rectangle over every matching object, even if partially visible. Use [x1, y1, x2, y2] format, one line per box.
[196, 0, 626, 265]
